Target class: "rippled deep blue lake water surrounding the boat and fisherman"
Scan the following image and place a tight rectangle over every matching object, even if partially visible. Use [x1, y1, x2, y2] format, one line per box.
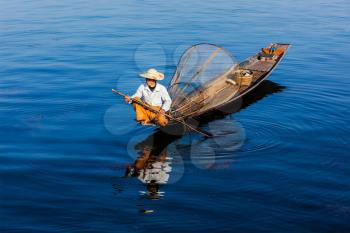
[0, 0, 350, 233]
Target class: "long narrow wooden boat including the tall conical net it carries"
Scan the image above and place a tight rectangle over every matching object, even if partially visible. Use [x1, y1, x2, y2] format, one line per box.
[161, 43, 290, 133]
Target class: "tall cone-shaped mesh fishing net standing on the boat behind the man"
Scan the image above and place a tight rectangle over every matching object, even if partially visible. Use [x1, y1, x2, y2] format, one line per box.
[169, 44, 237, 116]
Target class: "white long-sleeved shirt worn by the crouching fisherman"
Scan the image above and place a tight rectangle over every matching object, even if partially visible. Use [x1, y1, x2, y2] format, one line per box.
[131, 83, 171, 111]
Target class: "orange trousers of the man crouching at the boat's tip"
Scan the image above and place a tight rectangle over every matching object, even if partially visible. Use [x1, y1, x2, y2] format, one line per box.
[133, 98, 168, 126]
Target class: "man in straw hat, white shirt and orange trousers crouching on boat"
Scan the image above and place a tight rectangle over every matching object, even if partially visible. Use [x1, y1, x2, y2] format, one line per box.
[125, 68, 171, 126]
